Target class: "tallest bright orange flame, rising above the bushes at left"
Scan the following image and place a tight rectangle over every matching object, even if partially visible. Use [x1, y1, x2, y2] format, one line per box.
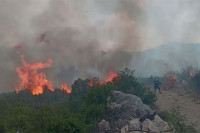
[15, 55, 54, 95]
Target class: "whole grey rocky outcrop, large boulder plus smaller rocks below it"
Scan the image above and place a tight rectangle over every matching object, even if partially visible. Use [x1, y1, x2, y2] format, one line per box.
[97, 91, 170, 133]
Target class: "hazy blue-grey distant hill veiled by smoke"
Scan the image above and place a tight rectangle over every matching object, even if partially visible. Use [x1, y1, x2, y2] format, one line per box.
[131, 44, 200, 76]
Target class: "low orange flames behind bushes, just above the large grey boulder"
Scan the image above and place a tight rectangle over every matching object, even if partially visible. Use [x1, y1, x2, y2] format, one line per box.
[88, 70, 119, 86]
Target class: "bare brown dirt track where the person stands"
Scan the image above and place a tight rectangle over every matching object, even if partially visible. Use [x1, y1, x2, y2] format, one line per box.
[157, 88, 200, 131]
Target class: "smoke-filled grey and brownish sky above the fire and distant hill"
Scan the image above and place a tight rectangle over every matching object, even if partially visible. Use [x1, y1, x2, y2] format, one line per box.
[0, 0, 200, 91]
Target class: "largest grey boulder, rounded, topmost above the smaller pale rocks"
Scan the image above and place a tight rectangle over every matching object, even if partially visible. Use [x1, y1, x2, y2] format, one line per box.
[109, 91, 154, 120]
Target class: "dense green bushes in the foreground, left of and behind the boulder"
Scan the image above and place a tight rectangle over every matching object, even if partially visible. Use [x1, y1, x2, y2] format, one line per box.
[0, 68, 156, 133]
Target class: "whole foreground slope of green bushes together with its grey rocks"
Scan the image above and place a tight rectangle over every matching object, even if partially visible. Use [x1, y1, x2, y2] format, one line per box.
[0, 68, 196, 133]
